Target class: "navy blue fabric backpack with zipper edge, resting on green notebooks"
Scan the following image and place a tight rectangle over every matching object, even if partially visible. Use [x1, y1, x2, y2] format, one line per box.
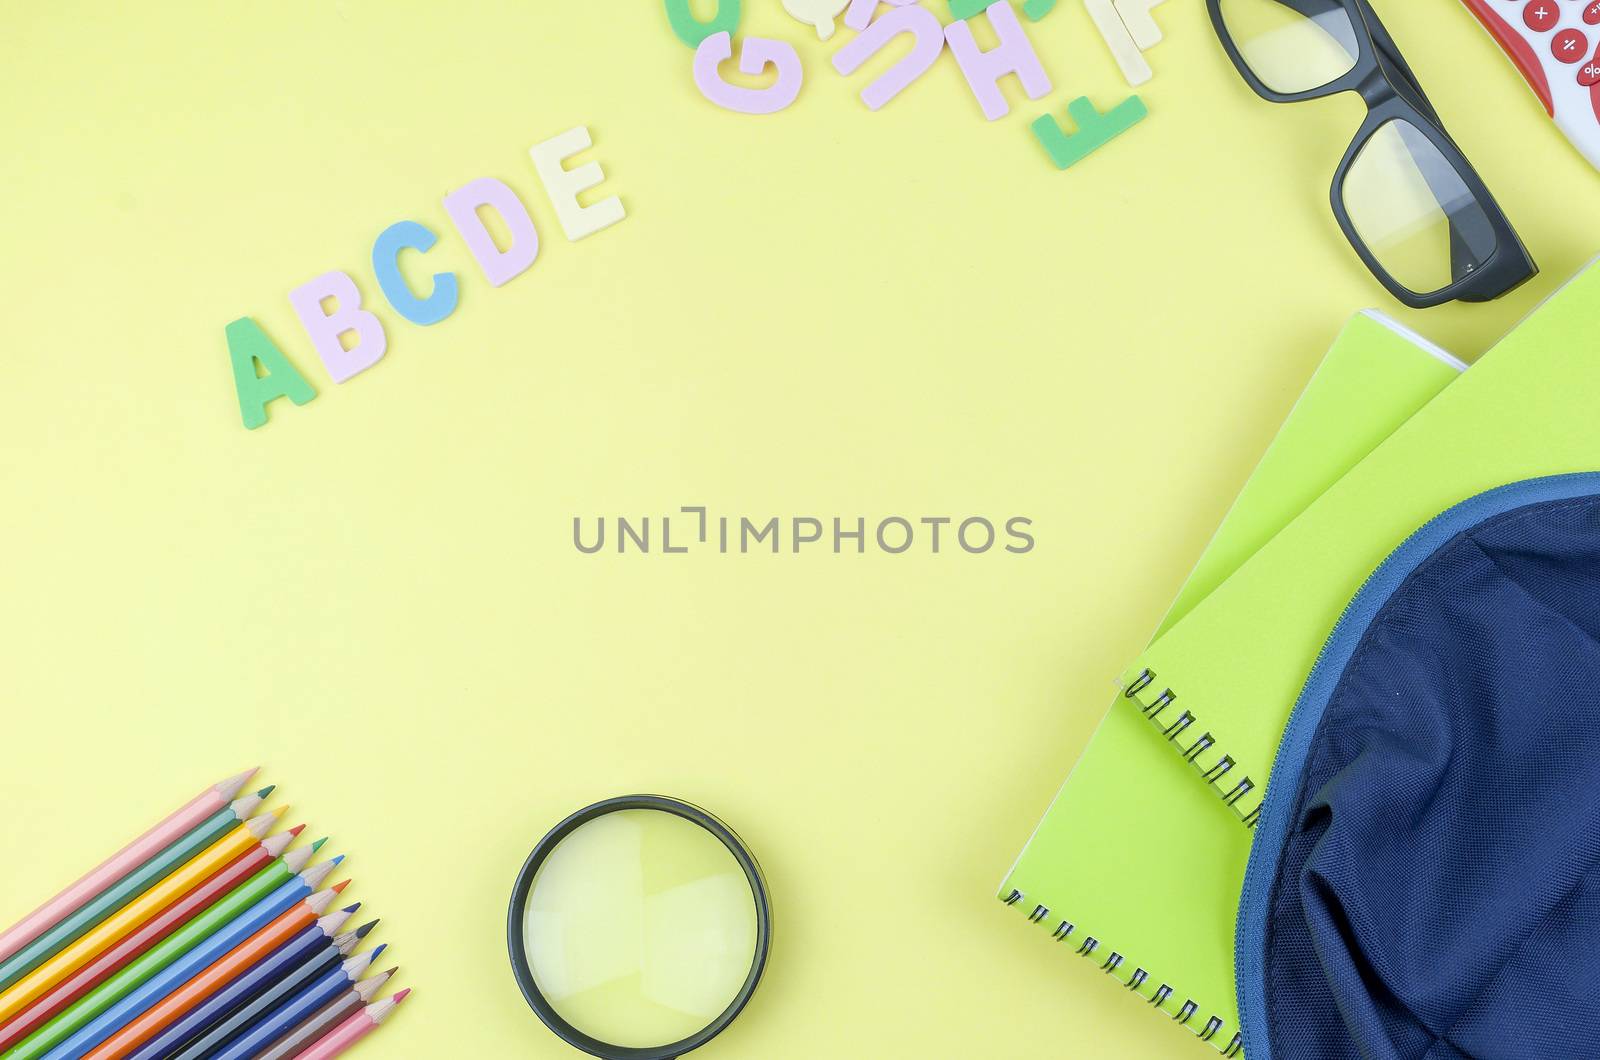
[1238, 476, 1600, 1060]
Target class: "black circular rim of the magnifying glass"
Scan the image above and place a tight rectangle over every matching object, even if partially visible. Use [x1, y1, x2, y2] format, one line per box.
[506, 794, 773, 1060]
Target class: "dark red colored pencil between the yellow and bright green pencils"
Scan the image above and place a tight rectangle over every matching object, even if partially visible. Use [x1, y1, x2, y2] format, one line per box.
[0, 828, 305, 1052]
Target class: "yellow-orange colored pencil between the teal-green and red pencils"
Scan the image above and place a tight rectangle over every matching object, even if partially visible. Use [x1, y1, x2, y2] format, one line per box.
[0, 815, 294, 1023]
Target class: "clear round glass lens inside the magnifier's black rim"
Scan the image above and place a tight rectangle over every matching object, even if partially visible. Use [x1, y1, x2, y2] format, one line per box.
[523, 809, 758, 1049]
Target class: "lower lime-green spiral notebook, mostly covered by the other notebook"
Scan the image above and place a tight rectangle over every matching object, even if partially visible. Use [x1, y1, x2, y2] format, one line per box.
[1000, 312, 1464, 1054]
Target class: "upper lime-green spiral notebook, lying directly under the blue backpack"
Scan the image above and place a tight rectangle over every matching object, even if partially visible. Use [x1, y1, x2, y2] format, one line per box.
[1123, 263, 1600, 832]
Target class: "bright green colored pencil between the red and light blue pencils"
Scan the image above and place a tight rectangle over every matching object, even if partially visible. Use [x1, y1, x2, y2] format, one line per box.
[5, 839, 333, 1060]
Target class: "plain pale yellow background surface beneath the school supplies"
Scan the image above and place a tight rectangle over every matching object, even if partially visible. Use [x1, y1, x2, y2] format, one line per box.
[0, 0, 1600, 1060]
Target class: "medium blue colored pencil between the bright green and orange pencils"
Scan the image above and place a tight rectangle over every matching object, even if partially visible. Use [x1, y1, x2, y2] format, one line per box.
[34, 861, 336, 1060]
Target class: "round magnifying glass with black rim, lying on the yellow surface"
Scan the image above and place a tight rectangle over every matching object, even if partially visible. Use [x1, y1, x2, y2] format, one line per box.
[506, 796, 773, 1060]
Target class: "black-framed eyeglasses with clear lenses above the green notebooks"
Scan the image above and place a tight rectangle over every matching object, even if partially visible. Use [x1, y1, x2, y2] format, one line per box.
[1206, 0, 1539, 309]
